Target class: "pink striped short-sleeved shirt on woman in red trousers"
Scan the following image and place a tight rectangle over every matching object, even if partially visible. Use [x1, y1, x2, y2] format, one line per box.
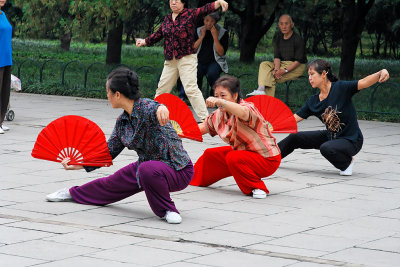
[206, 100, 280, 158]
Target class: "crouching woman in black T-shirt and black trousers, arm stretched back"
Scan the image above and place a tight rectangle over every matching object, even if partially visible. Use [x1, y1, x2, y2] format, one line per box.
[278, 59, 389, 176]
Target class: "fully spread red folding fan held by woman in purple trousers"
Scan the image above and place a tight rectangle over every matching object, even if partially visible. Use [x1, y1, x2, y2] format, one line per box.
[32, 115, 112, 167]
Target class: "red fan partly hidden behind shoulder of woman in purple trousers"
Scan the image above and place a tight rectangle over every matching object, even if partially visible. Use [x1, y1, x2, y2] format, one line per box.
[155, 94, 203, 142]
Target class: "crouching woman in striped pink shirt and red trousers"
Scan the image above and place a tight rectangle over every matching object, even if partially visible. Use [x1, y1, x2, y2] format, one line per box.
[190, 75, 281, 198]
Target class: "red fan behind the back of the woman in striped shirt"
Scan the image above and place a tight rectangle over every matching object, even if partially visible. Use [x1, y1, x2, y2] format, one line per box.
[245, 95, 297, 133]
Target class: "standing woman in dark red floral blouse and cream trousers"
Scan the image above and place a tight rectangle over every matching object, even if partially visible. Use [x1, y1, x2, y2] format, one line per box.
[136, 0, 228, 121]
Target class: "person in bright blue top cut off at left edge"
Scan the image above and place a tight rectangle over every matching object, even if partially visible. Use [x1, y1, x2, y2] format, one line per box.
[0, 0, 12, 134]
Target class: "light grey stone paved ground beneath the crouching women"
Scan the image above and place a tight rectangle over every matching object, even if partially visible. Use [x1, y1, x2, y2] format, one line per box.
[0, 93, 400, 267]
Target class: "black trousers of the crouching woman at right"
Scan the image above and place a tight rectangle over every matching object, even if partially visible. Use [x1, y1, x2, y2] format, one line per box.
[278, 131, 363, 171]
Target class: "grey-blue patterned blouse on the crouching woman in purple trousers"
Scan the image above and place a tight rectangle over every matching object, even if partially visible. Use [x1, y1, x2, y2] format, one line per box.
[85, 98, 191, 187]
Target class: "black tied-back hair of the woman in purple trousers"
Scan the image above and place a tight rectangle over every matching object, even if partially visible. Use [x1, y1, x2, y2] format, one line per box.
[107, 68, 140, 101]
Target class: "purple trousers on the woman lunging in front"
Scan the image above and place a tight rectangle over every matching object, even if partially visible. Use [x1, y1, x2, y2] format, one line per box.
[69, 161, 194, 217]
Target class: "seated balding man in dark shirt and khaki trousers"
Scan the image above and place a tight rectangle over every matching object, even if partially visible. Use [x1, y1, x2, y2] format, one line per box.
[248, 14, 307, 96]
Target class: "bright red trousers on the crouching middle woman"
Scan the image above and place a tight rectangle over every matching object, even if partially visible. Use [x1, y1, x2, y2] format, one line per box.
[190, 146, 281, 195]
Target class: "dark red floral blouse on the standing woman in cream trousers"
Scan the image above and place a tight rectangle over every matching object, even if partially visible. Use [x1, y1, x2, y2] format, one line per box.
[146, 2, 215, 60]
